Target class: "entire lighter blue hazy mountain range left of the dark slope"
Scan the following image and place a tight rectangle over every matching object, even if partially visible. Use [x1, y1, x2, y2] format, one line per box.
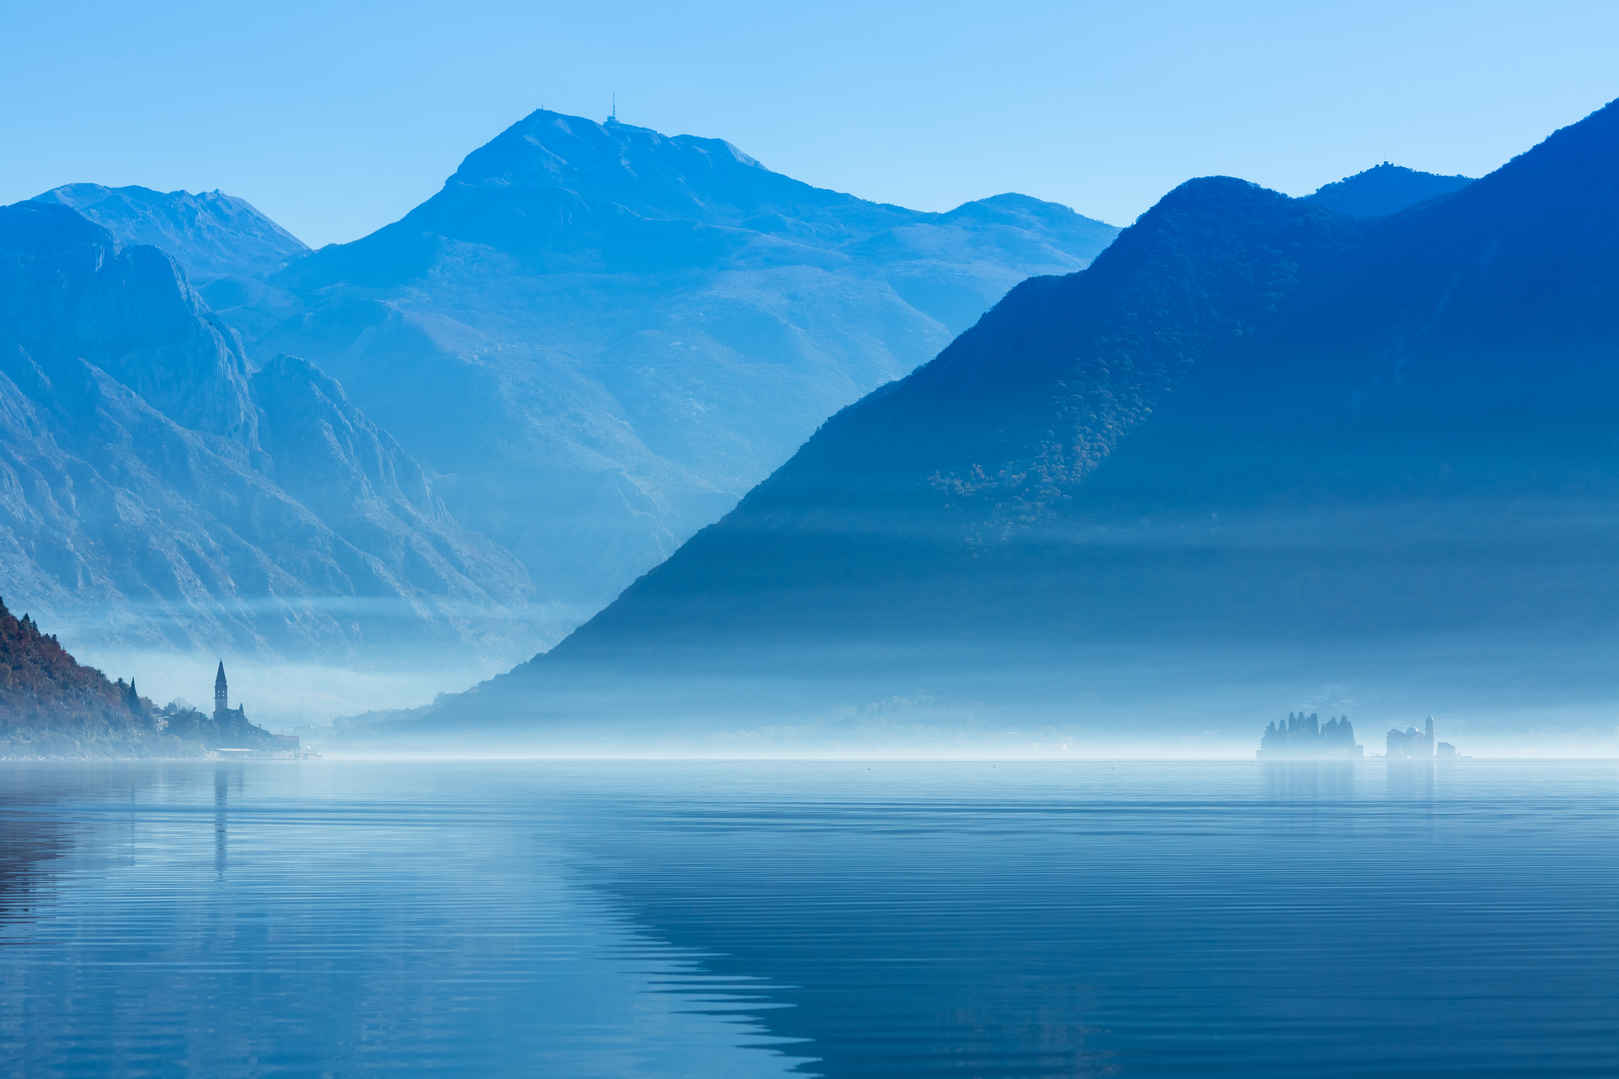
[9, 112, 1115, 673]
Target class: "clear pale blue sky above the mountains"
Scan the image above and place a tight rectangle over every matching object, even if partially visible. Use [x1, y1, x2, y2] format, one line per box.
[0, 0, 1619, 245]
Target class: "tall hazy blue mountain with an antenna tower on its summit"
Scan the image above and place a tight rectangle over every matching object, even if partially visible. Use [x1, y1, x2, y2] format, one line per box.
[239, 112, 1115, 611]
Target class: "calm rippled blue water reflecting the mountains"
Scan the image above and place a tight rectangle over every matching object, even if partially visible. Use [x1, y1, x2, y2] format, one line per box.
[0, 761, 1619, 1077]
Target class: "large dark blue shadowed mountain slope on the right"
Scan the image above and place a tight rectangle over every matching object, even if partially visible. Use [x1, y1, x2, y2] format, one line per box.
[370, 98, 1619, 748]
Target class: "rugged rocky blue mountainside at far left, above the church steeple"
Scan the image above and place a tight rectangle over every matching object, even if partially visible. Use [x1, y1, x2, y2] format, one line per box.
[0, 201, 528, 659]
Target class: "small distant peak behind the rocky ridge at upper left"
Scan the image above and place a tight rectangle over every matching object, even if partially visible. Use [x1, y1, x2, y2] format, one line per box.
[36, 183, 309, 287]
